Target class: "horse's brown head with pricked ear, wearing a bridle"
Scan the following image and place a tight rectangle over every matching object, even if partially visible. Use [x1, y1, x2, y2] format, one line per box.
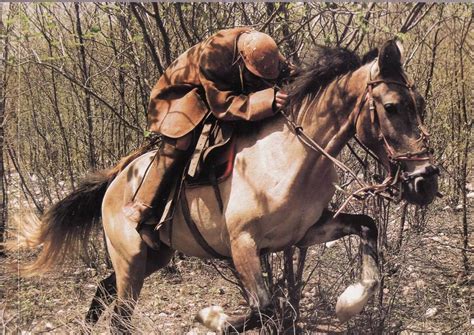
[355, 40, 439, 205]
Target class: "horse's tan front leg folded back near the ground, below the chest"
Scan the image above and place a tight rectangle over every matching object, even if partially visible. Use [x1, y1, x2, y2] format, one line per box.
[198, 232, 271, 333]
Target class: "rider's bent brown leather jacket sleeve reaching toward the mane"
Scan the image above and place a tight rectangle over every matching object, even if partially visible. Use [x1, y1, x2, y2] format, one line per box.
[200, 46, 275, 121]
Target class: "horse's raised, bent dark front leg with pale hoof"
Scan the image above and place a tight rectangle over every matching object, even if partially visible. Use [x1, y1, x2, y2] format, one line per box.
[297, 210, 380, 322]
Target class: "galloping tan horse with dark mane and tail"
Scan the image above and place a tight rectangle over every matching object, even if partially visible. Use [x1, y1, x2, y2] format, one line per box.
[21, 41, 438, 331]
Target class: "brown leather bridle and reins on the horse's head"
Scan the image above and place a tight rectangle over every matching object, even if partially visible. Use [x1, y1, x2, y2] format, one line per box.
[279, 64, 439, 218]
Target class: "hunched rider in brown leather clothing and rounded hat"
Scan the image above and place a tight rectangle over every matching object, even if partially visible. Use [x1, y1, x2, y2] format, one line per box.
[124, 28, 290, 248]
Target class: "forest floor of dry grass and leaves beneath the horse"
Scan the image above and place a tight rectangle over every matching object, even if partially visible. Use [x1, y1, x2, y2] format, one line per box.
[0, 200, 474, 334]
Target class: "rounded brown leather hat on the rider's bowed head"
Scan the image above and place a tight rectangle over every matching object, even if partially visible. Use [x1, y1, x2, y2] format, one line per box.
[237, 30, 285, 80]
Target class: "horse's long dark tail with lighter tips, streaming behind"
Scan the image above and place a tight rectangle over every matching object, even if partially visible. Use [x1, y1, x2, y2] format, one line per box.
[16, 145, 157, 276]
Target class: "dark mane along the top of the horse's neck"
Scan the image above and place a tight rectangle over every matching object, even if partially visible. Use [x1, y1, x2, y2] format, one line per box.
[287, 46, 378, 109]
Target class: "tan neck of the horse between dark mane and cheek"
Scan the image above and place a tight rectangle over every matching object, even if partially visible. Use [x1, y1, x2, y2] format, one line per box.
[297, 66, 368, 160]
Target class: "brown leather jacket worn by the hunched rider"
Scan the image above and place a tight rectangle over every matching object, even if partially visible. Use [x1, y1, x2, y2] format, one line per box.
[148, 28, 275, 138]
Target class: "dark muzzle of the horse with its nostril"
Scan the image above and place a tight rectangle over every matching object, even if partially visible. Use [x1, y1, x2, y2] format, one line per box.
[402, 164, 439, 206]
